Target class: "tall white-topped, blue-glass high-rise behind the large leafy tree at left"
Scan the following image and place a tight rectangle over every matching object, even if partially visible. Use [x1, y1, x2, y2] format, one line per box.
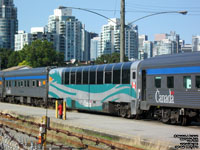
[47, 6, 89, 61]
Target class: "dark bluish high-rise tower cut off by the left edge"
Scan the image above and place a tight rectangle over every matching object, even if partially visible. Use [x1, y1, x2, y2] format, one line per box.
[0, 0, 18, 50]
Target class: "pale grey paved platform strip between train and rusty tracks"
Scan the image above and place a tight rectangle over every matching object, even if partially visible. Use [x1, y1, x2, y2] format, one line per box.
[0, 103, 200, 149]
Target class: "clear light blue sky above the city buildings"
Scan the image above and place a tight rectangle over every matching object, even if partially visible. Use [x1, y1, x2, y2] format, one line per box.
[14, 0, 200, 43]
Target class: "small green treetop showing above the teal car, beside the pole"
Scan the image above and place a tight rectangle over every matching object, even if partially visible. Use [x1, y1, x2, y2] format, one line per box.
[95, 53, 128, 64]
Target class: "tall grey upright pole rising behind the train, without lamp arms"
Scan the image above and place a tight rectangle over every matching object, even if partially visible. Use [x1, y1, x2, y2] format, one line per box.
[120, 0, 125, 62]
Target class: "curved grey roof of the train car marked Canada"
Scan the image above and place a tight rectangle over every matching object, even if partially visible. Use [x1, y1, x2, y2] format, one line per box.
[141, 52, 200, 69]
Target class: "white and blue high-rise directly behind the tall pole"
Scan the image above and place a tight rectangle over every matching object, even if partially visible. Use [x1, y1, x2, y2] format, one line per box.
[98, 18, 138, 59]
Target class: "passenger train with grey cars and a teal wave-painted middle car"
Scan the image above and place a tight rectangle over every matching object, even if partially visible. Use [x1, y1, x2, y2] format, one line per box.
[0, 52, 200, 125]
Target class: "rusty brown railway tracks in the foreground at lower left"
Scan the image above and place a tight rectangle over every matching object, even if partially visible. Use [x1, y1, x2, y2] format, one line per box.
[0, 113, 143, 150]
